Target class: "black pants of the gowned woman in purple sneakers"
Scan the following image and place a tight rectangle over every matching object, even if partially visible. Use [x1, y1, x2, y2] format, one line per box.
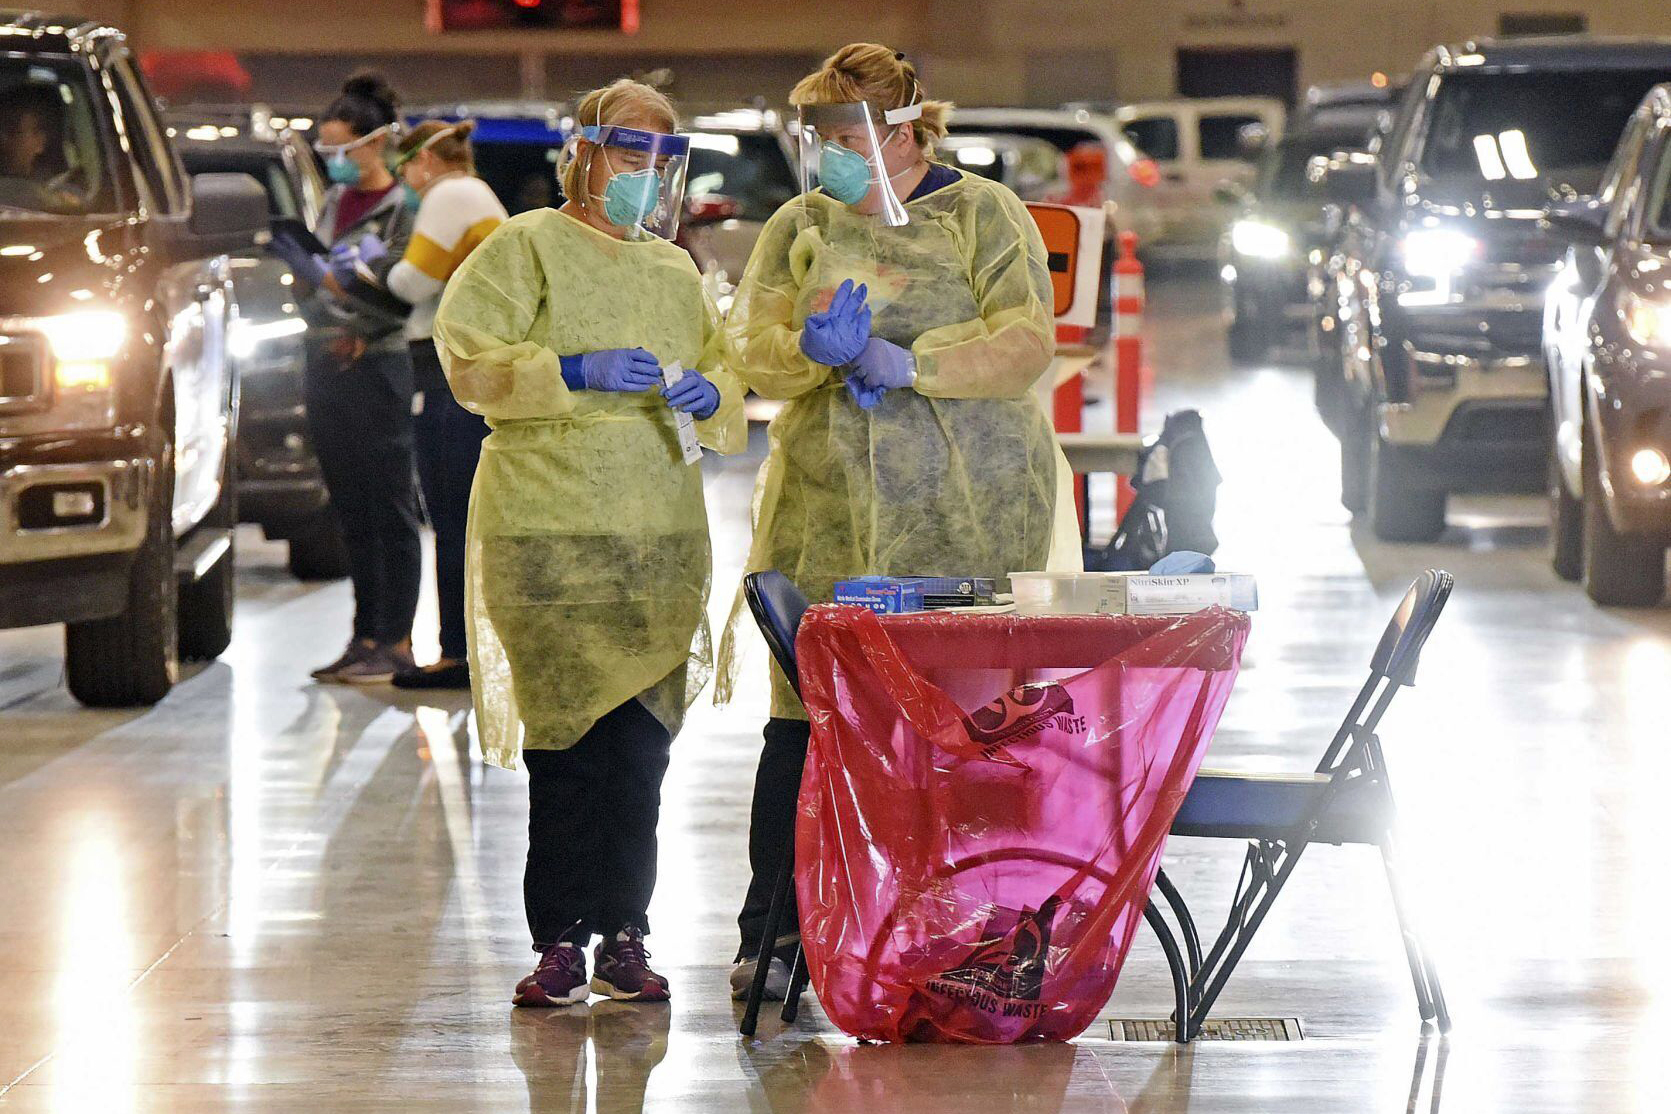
[523, 700, 673, 949]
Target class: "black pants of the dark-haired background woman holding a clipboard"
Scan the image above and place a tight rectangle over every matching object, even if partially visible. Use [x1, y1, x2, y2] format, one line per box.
[306, 349, 423, 643]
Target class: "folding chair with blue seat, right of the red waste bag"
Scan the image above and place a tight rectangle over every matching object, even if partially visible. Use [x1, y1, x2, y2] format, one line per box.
[1150, 570, 1454, 1042]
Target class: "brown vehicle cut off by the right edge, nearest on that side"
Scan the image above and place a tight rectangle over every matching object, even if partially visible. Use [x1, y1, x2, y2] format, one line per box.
[1544, 85, 1671, 605]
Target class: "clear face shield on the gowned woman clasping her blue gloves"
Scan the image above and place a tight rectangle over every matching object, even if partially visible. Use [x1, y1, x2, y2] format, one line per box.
[795, 100, 922, 227]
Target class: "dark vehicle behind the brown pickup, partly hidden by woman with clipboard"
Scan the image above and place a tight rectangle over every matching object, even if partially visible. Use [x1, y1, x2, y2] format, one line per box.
[169, 109, 348, 580]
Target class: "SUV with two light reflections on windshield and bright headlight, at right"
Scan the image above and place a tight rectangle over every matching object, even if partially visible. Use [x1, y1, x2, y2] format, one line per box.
[1323, 37, 1671, 541]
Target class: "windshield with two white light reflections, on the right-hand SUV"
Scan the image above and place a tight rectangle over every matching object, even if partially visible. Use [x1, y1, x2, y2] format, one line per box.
[1422, 68, 1671, 194]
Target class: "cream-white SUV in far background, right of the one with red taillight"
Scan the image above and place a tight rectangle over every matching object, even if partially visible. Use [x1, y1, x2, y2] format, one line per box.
[1115, 97, 1287, 256]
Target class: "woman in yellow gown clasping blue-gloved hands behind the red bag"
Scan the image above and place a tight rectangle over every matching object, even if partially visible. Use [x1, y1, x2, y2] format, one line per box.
[720, 43, 1079, 997]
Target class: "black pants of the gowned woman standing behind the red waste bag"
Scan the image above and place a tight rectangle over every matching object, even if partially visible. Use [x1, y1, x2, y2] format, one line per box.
[737, 718, 812, 959]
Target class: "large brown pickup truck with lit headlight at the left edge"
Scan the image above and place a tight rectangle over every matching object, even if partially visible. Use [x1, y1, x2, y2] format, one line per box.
[0, 13, 267, 706]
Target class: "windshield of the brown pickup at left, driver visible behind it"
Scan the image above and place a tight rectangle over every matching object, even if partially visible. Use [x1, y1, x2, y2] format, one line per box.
[0, 57, 115, 215]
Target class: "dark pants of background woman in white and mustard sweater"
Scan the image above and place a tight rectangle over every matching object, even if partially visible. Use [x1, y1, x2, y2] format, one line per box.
[409, 341, 488, 658]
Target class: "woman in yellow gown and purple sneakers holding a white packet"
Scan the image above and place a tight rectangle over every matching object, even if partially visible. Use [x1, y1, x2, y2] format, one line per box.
[434, 80, 747, 1005]
